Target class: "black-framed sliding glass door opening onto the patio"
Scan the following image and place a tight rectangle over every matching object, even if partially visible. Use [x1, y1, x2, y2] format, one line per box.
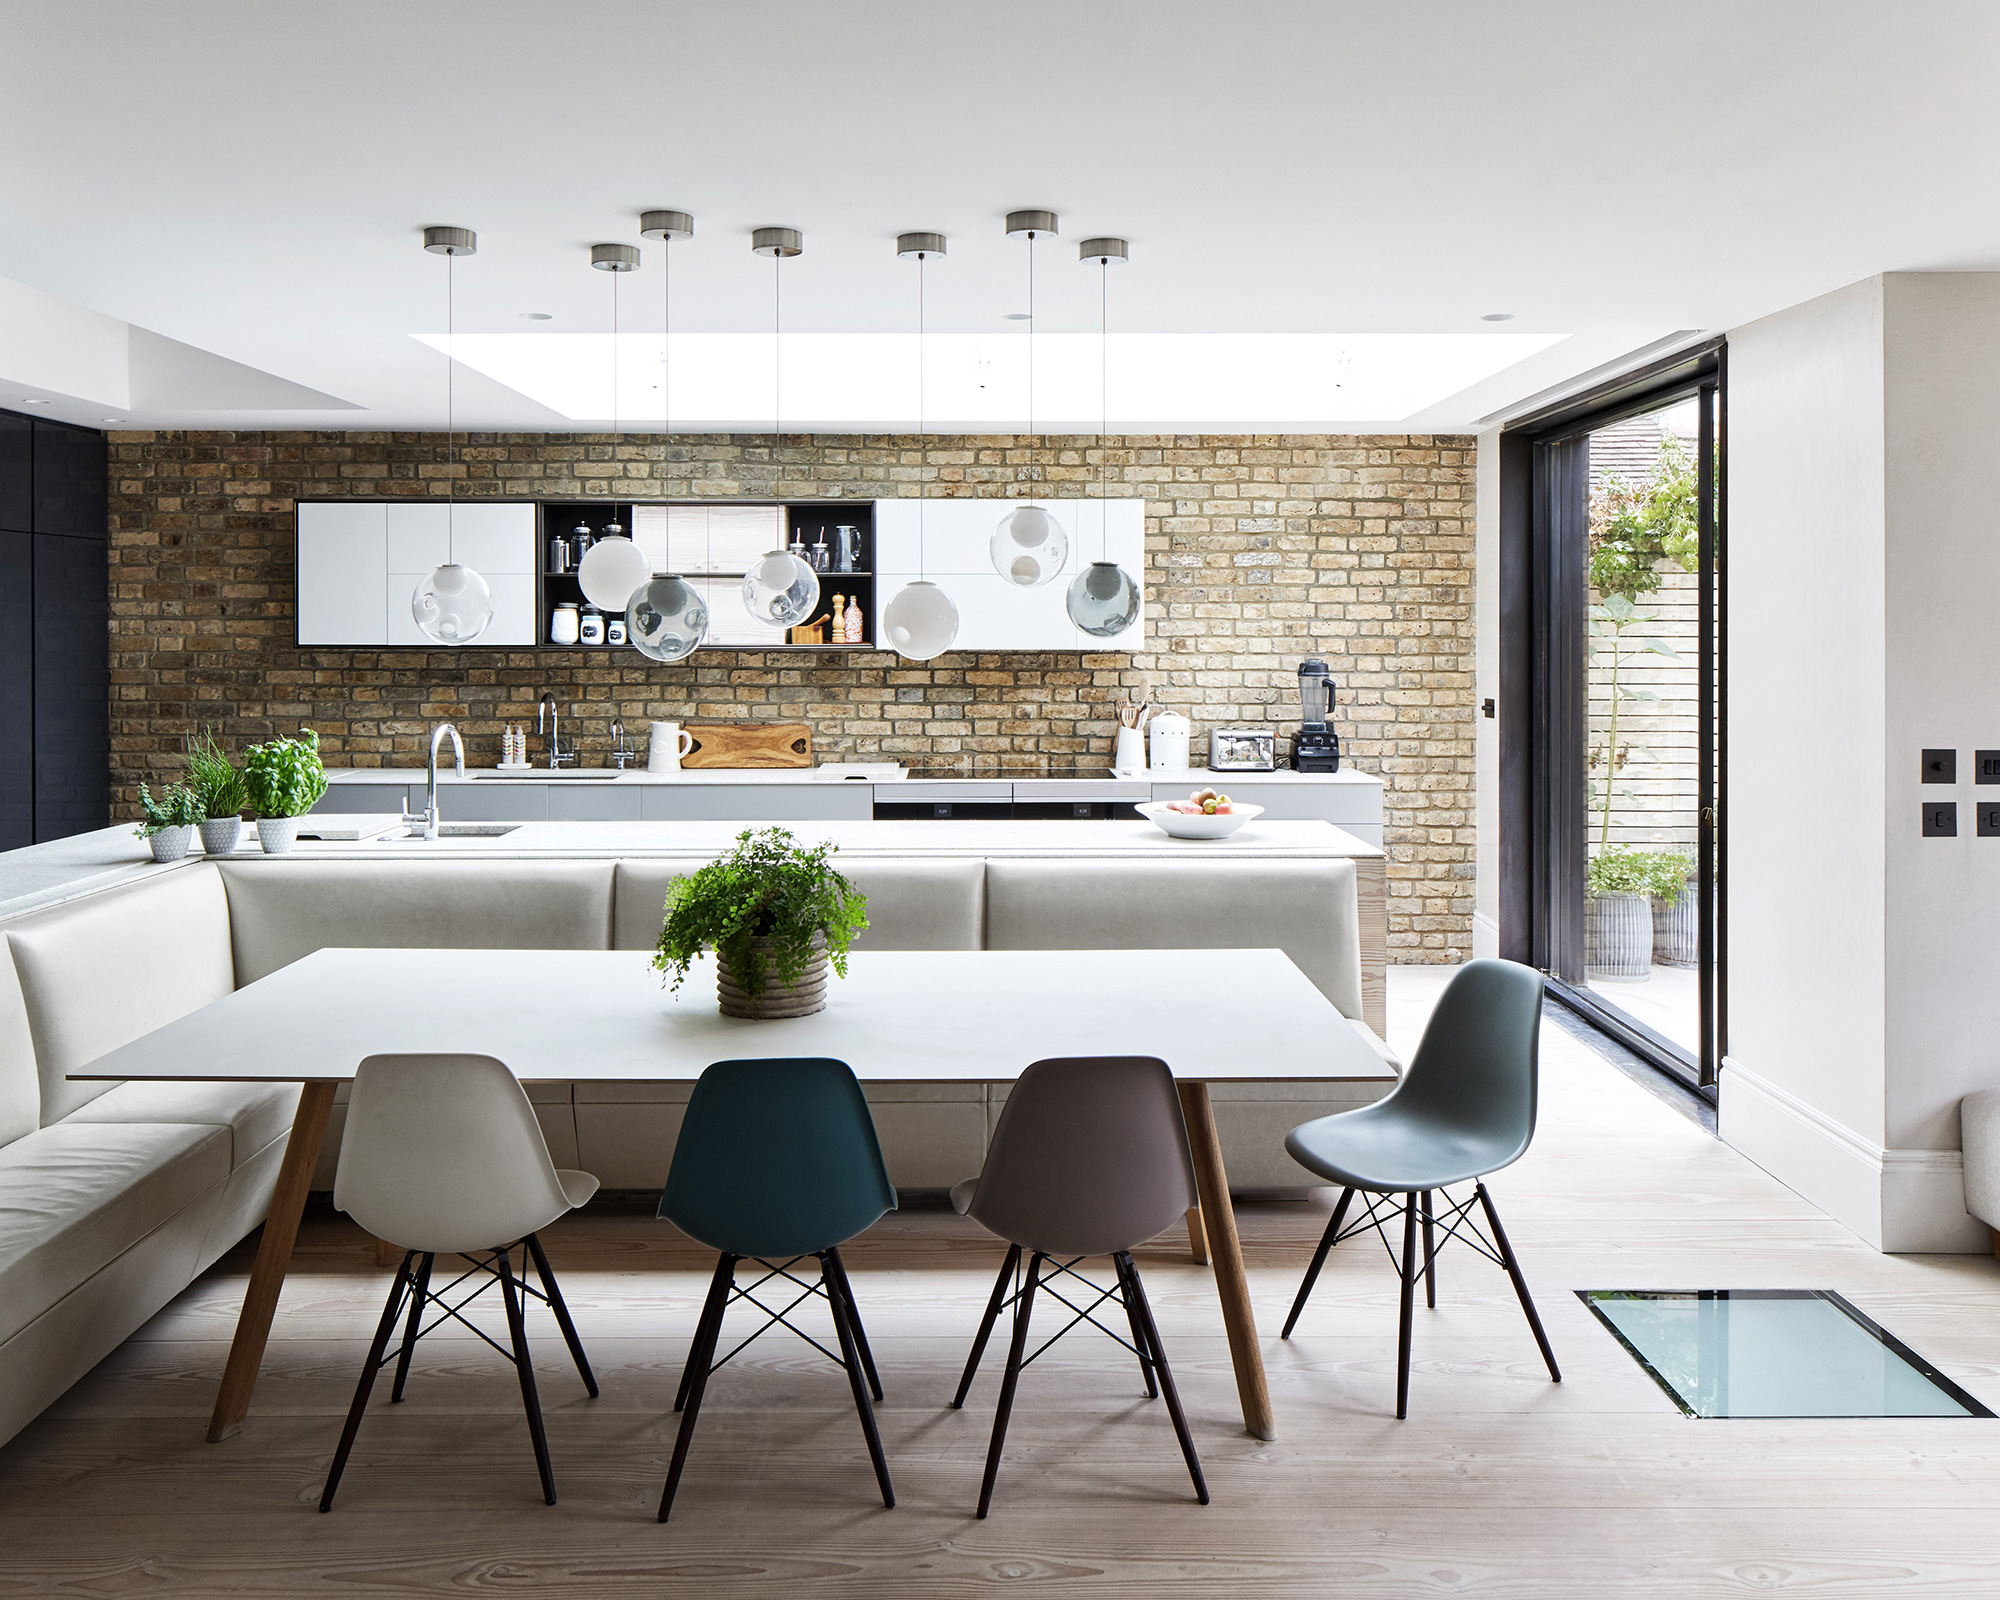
[1502, 350, 1726, 1088]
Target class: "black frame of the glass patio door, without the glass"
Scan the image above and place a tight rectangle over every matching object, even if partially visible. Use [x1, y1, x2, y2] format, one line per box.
[1498, 338, 1728, 1098]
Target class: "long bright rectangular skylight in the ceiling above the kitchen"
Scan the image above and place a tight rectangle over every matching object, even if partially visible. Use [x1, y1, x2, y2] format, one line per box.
[414, 332, 1566, 432]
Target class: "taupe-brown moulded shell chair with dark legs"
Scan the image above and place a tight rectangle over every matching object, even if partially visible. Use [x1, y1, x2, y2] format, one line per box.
[952, 1056, 1208, 1516]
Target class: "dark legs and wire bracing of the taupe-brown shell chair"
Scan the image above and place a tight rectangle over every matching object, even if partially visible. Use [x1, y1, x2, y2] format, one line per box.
[952, 1244, 1208, 1518]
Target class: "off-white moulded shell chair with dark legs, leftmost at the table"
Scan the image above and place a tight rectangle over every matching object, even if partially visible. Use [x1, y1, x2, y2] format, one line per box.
[320, 1056, 598, 1512]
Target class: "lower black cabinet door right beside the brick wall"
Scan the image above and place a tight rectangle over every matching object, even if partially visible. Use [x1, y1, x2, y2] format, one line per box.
[34, 534, 110, 844]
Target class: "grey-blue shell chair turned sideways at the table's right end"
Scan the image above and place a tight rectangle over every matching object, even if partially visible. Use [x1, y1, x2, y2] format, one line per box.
[1280, 960, 1562, 1420]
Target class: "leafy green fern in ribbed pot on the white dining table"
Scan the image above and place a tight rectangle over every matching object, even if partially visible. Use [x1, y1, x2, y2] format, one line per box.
[652, 828, 868, 1018]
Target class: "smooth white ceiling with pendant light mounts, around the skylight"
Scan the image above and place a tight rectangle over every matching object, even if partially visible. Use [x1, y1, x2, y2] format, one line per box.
[0, 0, 2000, 430]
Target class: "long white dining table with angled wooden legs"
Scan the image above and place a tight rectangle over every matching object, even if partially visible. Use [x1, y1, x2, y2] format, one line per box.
[70, 950, 1396, 1440]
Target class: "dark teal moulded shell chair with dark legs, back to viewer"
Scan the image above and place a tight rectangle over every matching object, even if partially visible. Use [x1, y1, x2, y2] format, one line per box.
[660, 1056, 896, 1522]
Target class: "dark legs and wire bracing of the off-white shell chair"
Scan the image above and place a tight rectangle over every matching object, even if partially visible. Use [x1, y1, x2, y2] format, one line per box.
[320, 1234, 598, 1512]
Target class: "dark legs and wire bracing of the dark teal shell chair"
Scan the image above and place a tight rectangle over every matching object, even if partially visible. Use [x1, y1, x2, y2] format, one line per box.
[660, 1250, 896, 1522]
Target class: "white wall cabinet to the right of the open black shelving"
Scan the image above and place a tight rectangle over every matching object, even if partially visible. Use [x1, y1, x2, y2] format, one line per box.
[874, 500, 1146, 650]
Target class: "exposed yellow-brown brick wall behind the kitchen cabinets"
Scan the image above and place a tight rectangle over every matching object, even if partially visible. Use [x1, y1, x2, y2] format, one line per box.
[110, 432, 1474, 960]
